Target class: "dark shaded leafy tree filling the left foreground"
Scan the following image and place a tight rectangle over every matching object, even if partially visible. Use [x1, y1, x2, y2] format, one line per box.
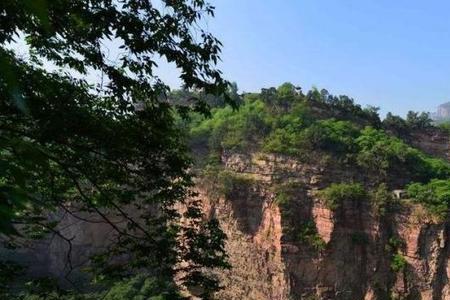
[0, 0, 233, 297]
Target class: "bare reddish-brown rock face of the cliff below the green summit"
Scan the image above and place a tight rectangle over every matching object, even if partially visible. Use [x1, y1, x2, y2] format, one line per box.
[198, 154, 450, 300]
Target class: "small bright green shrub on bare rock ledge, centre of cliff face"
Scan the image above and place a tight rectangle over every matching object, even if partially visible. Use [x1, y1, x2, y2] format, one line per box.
[319, 183, 368, 210]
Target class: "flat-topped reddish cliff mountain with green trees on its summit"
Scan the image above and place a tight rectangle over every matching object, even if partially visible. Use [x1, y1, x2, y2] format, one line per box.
[190, 85, 450, 300]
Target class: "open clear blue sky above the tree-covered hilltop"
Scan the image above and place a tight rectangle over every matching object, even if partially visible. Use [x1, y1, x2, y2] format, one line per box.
[164, 0, 450, 115]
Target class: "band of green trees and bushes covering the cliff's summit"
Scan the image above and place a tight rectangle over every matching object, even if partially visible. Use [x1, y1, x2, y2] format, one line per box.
[190, 83, 450, 182]
